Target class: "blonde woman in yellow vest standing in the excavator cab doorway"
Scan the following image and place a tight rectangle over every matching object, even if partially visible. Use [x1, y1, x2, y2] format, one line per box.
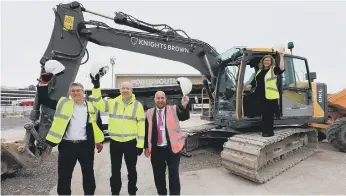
[247, 55, 285, 137]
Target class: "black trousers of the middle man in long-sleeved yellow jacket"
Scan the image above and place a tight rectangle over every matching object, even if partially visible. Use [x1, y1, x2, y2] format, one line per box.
[110, 139, 138, 195]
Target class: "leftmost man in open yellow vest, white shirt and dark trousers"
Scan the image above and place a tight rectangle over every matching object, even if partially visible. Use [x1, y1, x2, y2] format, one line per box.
[37, 73, 104, 195]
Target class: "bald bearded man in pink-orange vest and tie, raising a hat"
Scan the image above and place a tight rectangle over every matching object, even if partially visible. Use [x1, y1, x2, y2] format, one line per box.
[144, 91, 190, 195]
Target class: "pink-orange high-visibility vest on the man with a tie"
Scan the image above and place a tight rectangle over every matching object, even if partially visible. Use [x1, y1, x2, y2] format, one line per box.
[146, 105, 185, 153]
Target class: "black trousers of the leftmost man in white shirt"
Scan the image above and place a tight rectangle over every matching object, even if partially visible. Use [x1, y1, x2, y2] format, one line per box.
[57, 140, 96, 195]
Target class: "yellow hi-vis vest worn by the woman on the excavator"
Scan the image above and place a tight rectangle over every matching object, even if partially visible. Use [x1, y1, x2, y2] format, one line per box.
[255, 66, 280, 99]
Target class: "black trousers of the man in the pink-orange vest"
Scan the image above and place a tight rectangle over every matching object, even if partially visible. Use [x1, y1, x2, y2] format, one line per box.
[151, 146, 180, 195]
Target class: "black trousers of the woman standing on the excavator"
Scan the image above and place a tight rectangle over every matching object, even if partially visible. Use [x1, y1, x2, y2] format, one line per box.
[260, 98, 278, 136]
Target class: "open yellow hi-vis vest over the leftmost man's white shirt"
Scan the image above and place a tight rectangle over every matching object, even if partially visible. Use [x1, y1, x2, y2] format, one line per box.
[46, 97, 104, 144]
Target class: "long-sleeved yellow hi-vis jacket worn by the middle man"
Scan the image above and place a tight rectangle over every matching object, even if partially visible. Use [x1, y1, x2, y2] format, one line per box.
[92, 88, 145, 148]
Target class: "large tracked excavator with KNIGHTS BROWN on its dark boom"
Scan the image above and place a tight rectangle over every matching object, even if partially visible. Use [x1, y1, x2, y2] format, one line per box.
[1, 1, 340, 183]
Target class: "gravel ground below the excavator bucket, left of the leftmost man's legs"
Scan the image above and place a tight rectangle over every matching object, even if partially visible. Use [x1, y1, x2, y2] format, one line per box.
[1, 152, 58, 195]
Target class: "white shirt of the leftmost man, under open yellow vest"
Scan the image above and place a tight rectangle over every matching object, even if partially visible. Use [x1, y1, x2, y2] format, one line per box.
[64, 101, 88, 140]
